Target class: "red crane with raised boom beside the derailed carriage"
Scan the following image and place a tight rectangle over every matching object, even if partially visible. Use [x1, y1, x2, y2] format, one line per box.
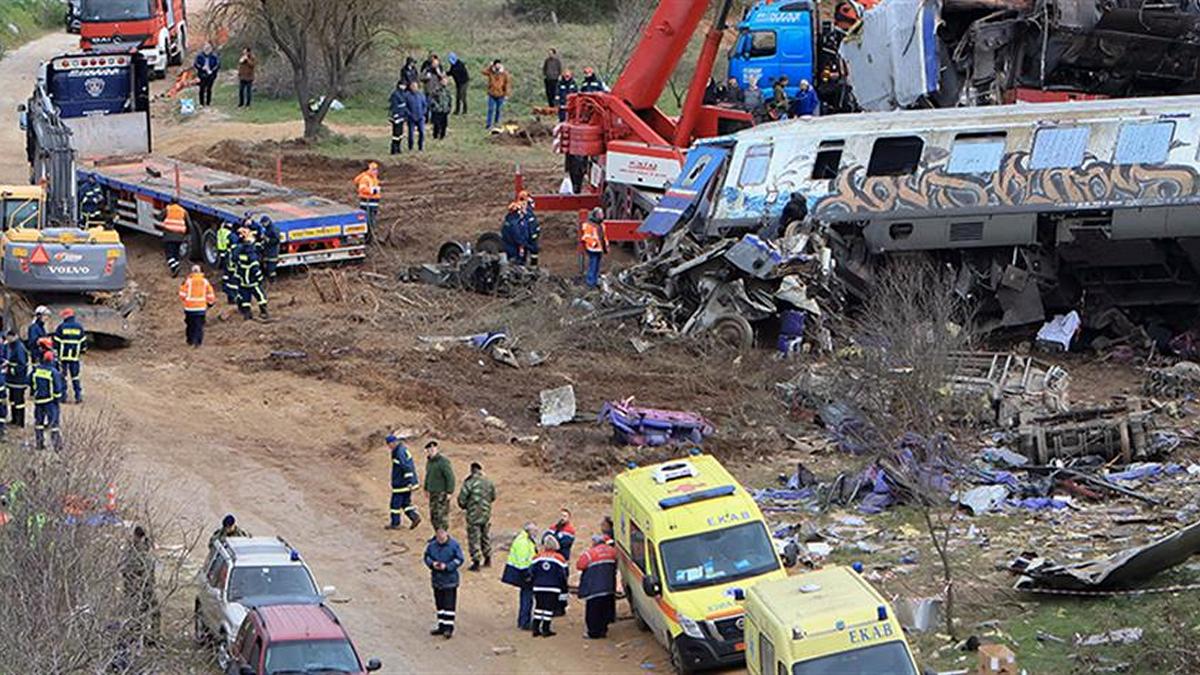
[516, 0, 754, 241]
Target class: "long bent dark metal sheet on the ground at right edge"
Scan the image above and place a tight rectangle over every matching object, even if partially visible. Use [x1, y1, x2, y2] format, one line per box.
[1013, 521, 1200, 591]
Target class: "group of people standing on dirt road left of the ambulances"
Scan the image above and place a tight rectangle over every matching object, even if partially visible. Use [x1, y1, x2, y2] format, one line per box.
[385, 431, 617, 639]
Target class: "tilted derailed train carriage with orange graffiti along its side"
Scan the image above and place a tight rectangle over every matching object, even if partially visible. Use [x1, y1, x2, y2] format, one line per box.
[662, 96, 1200, 325]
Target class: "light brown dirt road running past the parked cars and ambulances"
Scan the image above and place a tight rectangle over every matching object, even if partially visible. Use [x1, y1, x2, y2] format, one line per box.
[0, 27, 666, 673]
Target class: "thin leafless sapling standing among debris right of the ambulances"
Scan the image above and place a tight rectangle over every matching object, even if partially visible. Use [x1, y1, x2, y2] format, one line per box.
[830, 258, 972, 635]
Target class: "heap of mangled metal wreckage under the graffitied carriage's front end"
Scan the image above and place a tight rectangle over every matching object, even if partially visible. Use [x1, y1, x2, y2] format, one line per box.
[598, 231, 841, 353]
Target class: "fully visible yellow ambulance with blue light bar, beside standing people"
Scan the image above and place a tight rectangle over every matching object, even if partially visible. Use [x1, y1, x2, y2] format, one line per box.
[613, 452, 787, 673]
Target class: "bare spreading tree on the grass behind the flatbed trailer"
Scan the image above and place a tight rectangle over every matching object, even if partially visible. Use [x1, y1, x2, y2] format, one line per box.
[212, 0, 394, 138]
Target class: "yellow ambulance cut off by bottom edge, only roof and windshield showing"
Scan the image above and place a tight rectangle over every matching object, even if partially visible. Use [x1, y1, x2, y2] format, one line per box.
[745, 567, 919, 675]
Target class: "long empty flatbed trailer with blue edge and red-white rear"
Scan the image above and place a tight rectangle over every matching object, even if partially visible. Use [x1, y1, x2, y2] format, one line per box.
[76, 155, 368, 268]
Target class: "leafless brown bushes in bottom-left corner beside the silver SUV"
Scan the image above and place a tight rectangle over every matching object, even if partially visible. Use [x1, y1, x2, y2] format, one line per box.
[0, 413, 200, 674]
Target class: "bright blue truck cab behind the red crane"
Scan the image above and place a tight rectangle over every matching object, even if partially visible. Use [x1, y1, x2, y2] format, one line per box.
[730, 0, 817, 98]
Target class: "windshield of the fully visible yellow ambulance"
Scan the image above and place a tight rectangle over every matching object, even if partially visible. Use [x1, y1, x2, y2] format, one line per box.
[659, 521, 780, 591]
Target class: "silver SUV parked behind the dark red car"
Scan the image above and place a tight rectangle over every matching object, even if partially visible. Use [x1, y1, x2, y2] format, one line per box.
[193, 537, 335, 671]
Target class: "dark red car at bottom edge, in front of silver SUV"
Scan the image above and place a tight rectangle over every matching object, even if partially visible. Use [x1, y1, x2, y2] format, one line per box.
[227, 604, 383, 675]
